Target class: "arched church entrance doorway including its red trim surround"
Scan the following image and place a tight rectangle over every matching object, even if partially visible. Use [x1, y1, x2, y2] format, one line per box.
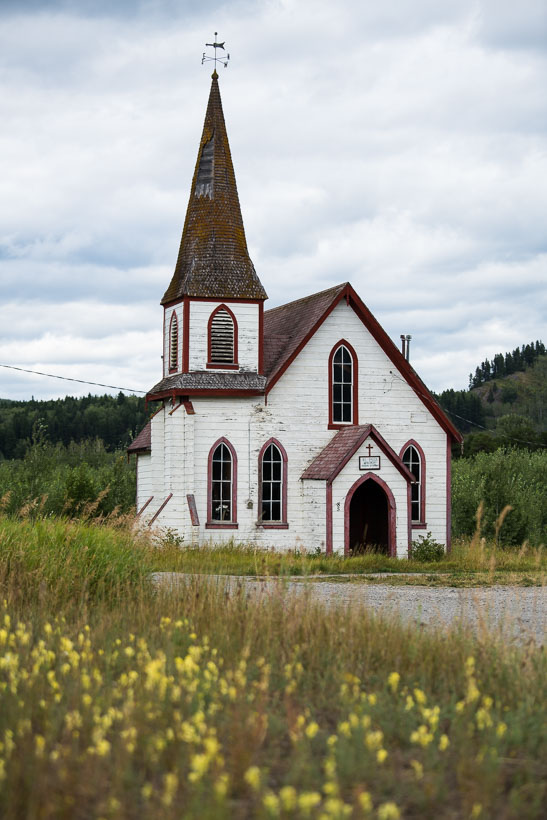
[345, 474, 396, 555]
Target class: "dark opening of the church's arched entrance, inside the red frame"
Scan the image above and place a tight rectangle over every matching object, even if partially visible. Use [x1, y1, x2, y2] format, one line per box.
[349, 478, 389, 555]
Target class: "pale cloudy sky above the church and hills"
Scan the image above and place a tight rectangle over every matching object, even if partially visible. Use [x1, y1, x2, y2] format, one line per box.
[0, 0, 547, 399]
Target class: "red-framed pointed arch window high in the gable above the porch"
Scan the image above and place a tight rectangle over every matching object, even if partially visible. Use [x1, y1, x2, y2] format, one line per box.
[329, 339, 359, 429]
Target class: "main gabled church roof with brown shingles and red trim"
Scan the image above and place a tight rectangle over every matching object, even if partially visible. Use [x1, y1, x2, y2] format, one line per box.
[264, 282, 462, 441]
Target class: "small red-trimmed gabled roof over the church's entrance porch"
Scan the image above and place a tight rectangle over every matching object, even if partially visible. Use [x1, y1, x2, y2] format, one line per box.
[301, 424, 416, 483]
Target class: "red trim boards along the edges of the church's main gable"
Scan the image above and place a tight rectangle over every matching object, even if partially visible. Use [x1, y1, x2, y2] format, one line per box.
[266, 282, 463, 442]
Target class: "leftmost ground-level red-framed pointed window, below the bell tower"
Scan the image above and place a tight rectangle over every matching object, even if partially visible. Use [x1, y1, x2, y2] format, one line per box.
[205, 438, 237, 529]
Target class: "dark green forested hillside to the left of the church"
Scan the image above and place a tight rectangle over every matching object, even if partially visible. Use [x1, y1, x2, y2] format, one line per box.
[0, 392, 146, 460]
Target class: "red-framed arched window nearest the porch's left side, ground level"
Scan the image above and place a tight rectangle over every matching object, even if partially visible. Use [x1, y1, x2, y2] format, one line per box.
[258, 439, 288, 528]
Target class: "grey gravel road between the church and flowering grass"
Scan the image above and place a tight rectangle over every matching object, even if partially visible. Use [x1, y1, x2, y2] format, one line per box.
[152, 572, 547, 645]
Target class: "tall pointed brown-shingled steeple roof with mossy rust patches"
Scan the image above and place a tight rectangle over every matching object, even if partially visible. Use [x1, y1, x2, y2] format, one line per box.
[161, 71, 267, 304]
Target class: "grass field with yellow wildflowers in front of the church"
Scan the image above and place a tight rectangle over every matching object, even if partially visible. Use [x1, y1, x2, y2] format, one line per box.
[0, 518, 547, 820]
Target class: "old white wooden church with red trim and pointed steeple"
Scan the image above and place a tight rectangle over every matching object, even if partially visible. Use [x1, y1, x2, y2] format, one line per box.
[129, 71, 461, 557]
